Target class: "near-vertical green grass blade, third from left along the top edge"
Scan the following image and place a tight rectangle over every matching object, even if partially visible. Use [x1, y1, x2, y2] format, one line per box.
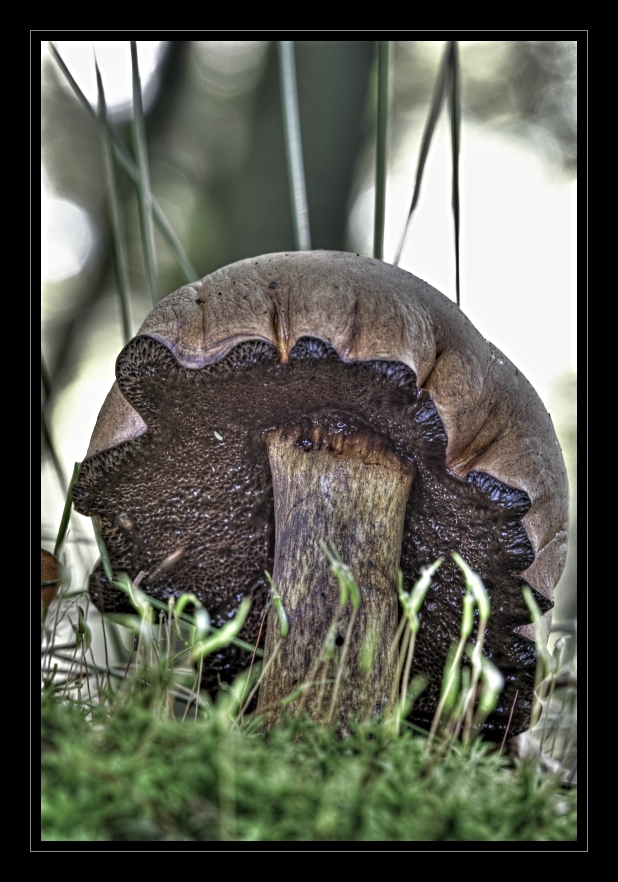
[131, 40, 159, 306]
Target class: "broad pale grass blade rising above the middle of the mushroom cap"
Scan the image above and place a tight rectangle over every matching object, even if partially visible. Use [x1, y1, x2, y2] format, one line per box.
[277, 40, 311, 251]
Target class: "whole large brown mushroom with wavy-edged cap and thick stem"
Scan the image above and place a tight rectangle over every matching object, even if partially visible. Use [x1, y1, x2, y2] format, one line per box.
[73, 251, 568, 740]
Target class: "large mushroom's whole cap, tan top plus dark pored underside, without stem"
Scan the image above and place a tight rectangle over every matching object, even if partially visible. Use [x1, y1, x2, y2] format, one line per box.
[73, 251, 568, 738]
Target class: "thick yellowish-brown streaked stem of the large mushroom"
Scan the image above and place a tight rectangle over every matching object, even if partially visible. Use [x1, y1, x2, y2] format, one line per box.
[257, 423, 415, 730]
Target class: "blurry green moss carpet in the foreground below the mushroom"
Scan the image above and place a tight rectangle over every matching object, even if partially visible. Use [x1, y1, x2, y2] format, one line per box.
[42, 695, 576, 842]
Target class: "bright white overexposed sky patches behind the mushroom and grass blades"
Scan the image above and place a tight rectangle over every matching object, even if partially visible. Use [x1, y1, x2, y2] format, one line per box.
[42, 44, 577, 548]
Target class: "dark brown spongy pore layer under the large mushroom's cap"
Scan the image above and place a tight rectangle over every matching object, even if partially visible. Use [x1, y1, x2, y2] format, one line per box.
[73, 337, 548, 740]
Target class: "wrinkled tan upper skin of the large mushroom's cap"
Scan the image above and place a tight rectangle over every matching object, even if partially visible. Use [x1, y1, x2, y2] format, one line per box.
[74, 251, 568, 734]
